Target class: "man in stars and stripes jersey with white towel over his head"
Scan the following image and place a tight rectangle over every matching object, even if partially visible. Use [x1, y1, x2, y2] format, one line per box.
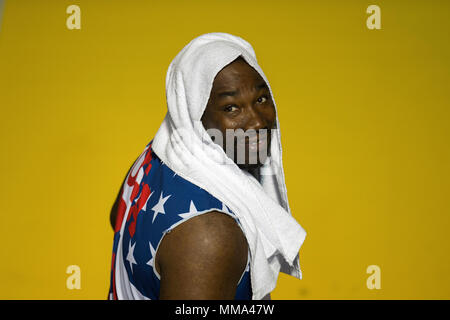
[110, 34, 305, 299]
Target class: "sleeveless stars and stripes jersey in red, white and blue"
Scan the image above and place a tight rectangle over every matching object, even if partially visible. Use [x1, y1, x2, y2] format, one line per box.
[108, 141, 252, 300]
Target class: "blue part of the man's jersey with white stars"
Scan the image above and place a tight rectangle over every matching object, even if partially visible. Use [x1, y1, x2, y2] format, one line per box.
[110, 142, 252, 300]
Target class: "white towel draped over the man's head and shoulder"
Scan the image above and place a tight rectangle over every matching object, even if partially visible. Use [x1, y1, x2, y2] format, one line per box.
[152, 33, 306, 300]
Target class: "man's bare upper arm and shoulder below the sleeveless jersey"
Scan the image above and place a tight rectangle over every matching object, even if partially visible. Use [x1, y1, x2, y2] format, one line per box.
[155, 211, 248, 300]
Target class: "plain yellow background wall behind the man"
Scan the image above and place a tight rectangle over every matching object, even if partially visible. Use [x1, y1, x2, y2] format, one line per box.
[0, 0, 450, 299]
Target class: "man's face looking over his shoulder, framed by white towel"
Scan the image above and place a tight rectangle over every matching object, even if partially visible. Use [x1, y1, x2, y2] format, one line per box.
[201, 58, 276, 169]
